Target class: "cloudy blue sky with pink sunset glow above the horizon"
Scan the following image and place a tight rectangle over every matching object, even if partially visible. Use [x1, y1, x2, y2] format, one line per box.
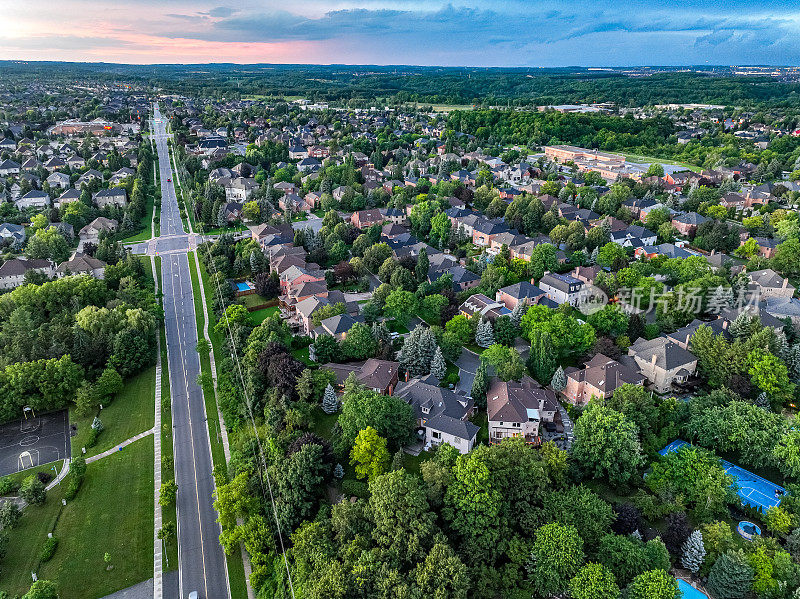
[0, 0, 800, 67]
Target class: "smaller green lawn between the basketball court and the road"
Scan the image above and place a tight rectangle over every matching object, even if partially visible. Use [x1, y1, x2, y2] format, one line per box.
[70, 366, 156, 457]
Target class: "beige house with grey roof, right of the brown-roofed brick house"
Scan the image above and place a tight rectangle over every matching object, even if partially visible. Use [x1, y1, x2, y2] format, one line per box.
[628, 337, 697, 393]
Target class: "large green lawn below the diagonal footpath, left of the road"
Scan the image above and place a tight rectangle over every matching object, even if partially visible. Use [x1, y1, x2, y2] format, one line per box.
[35, 438, 153, 599]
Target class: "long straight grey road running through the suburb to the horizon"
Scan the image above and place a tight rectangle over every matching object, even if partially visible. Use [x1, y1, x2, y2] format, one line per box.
[151, 104, 230, 599]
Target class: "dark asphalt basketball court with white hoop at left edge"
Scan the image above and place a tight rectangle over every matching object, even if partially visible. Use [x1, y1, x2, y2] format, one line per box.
[0, 410, 70, 476]
